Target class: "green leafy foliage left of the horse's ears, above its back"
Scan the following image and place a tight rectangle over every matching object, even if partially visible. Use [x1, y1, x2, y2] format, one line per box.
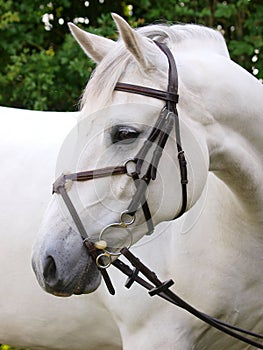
[0, 0, 121, 111]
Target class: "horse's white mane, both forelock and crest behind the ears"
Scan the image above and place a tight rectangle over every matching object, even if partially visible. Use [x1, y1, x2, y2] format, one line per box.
[81, 24, 229, 109]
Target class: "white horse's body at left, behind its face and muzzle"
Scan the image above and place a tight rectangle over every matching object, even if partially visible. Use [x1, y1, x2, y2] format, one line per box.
[0, 107, 120, 350]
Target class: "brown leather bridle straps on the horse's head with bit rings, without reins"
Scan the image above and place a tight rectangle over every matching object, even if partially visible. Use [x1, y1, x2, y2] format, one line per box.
[53, 42, 188, 262]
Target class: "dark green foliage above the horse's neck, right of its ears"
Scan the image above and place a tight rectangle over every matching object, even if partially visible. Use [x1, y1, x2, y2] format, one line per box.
[129, 0, 263, 79]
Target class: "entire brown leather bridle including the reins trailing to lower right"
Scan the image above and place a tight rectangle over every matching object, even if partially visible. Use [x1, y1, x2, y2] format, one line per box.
[53, 42, 263, 349]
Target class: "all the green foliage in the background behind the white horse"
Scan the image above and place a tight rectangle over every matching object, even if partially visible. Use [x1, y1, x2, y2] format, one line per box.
[0, 0, 263, 111]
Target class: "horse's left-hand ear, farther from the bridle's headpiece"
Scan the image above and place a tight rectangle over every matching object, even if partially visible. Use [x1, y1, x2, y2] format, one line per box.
[68, 23, 116, 63]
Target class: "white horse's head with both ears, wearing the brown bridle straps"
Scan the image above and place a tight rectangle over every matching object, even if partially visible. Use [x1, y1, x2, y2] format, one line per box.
[32, 15, 227, 296]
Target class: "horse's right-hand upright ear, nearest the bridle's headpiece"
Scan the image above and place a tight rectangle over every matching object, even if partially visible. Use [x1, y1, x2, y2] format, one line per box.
[111, 13, 152, 69]
